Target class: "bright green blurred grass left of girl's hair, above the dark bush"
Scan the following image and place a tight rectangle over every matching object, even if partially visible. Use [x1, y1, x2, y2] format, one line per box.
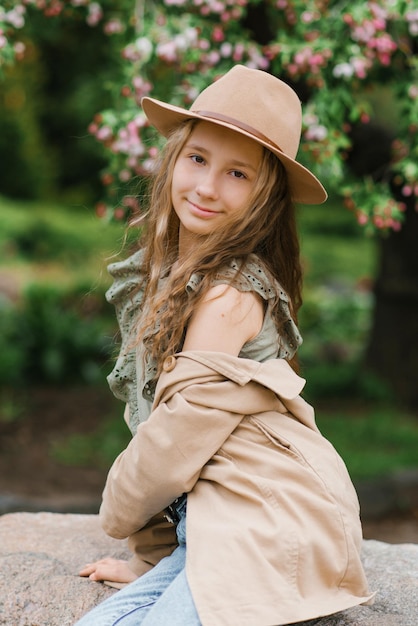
[0, 196, 131, 286]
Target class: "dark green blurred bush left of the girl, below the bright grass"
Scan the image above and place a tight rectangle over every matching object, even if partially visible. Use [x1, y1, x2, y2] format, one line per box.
[0, 285, 115, 387]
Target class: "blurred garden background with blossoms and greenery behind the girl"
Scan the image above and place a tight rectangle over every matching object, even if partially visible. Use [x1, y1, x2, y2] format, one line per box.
[0, 0, 418, 541]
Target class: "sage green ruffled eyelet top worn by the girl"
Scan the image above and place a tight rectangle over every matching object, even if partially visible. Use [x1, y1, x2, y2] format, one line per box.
[106, 250, 302, 434]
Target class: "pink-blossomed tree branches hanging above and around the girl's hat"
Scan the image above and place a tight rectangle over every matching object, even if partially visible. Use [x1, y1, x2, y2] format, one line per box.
[0, 0, 418, 401]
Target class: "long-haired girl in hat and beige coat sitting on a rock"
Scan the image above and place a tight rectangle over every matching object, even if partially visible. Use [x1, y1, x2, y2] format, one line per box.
[75, 66, 371, 626]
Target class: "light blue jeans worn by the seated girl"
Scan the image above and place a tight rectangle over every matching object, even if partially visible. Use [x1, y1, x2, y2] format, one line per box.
[75, 500, 201, 626]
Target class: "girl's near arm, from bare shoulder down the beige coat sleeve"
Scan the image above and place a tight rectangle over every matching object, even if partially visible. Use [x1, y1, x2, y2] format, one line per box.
[100, 285, 263, 538]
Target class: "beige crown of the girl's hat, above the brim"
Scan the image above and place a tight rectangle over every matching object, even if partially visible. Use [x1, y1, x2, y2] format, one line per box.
[190, 65, 302, 159]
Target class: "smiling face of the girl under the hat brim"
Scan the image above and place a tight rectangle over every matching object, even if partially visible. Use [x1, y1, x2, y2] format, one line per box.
[171, 122, 263, 245]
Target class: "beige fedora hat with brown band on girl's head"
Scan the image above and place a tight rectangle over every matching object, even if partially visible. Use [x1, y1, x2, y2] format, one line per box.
[141, 65, 327, 204]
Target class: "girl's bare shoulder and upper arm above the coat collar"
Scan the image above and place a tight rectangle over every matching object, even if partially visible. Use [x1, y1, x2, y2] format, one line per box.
[183, 285, 264, 356]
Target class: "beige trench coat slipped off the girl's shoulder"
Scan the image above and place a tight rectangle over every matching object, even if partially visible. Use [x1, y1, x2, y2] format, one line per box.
[100, 351, 372, 626]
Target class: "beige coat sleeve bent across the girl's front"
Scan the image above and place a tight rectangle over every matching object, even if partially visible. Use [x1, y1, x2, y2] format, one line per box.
[100, 371, 243, 539]
